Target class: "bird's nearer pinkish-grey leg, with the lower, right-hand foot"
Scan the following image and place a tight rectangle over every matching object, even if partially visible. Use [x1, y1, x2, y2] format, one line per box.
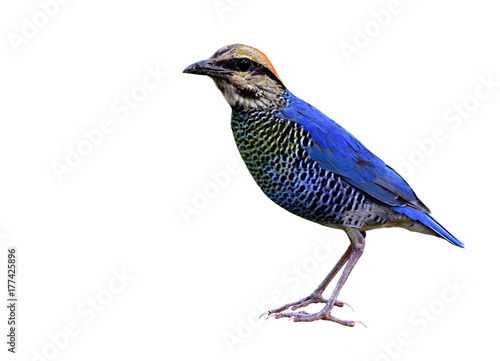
[269, 228, 365, 327]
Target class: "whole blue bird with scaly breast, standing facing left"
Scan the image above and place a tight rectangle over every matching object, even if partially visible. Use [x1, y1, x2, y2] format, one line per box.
[183, 44, 464, 327]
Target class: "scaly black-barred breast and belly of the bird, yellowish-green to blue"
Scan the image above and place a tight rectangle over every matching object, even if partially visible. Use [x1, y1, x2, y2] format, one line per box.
[231, 111, 376, 225]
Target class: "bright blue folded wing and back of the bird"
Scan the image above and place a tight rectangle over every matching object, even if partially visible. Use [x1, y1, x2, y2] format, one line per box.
[280, 94, 430, 213]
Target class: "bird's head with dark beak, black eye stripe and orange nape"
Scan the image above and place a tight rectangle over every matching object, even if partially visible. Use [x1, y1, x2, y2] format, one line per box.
[184, 44, 285, 109]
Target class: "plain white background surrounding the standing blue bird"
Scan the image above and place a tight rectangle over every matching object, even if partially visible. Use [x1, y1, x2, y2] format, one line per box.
[0, 0, 500, 361]
